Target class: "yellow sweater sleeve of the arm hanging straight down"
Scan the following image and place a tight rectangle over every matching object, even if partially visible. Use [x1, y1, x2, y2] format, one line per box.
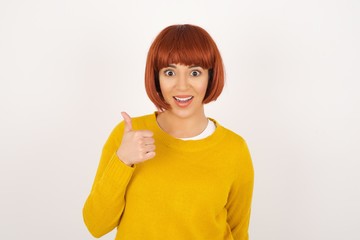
[226, 142, 254, 240]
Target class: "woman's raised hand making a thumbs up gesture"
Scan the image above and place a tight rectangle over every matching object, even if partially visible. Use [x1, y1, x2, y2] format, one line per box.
[117, 112, 155, 166]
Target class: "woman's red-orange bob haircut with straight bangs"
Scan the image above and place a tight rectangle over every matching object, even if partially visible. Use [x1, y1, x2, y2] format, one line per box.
[145, 24, 225, 110]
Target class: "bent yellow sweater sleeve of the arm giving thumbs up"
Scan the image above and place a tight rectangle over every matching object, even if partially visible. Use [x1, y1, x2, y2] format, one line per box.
[83, 123, 134, 238]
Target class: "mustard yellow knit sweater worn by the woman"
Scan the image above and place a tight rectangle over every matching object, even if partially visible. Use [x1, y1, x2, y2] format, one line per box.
[83, 113, 254, 240]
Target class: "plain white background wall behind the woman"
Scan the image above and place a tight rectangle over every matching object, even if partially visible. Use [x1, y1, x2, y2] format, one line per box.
[0, 0, 360, 240]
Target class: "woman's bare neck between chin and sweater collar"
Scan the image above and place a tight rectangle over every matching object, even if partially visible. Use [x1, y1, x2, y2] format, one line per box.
[157, 110, 208, 138]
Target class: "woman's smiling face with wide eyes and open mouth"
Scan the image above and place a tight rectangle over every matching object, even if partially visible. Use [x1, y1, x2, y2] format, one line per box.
[159, 64, 209, 118]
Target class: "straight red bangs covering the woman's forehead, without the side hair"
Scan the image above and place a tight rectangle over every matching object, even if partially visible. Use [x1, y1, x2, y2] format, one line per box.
[154, 26, 215, 71]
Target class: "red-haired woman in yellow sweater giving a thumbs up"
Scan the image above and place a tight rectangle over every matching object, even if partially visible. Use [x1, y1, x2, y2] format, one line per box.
[83, 25, 254, 240]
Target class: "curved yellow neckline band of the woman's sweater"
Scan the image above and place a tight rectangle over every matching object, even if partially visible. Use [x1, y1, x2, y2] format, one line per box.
[146, 111, 225, 152]
